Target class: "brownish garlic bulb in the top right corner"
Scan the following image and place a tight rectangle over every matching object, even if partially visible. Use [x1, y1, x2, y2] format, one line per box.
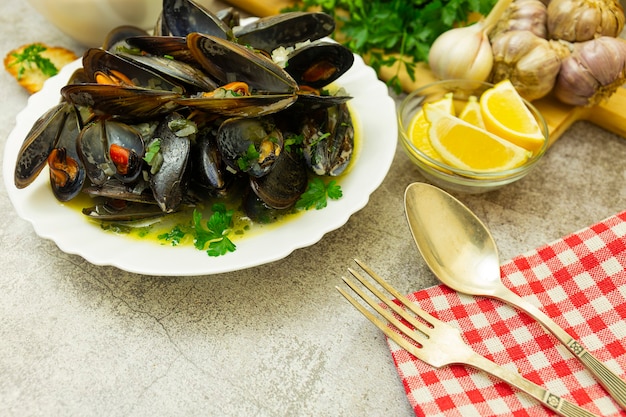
[547, 0, 624, 42]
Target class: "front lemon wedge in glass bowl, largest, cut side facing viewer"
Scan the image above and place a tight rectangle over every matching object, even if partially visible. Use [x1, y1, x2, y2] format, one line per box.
[424, 106, 532, 173]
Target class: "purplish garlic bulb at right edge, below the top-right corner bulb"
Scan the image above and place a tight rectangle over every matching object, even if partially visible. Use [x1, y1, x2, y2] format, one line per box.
[553, 36, 626, 106]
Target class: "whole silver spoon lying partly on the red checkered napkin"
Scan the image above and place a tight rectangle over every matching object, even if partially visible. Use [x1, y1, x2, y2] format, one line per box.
[404, 183, 626, 410]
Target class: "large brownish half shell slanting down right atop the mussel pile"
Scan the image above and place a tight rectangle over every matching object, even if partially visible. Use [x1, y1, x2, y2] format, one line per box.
[187, 33, 298, 94]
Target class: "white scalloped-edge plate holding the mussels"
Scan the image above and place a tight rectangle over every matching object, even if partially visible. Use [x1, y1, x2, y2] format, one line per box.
[4, 56, 397, 276]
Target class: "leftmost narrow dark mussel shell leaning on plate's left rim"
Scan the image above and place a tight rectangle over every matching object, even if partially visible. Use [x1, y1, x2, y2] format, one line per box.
[13, 102, 71, 188]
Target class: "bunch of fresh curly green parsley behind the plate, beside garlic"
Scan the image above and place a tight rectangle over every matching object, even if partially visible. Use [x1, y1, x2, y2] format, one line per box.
[295, 0, 495, 91]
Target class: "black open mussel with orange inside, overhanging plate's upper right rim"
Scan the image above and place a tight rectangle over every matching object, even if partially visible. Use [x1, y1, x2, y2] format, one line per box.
[285, 40, 354, 88]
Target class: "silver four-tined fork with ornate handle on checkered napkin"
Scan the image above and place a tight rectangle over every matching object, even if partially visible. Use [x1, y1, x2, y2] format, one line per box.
[336, 259, 595, 417]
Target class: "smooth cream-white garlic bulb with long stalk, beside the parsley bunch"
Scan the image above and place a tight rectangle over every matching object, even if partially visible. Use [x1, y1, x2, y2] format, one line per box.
[428, 0, 512, 81]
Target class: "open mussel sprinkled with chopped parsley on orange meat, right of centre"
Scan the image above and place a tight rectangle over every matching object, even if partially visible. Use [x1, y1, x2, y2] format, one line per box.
[217, 117, 284, 177]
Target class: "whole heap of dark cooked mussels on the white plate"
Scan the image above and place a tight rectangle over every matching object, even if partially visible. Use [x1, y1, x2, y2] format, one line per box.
[14, 0, 354, 224]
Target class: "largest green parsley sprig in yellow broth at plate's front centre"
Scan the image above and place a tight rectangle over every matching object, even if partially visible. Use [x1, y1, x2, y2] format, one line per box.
[192, 203, 236, 256]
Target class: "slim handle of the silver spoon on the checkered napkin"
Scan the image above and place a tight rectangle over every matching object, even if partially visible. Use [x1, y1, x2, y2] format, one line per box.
[497, 287, 626, 410]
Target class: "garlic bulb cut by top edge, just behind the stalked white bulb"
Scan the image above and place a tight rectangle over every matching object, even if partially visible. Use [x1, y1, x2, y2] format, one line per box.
[489, 0, 548, 39]
